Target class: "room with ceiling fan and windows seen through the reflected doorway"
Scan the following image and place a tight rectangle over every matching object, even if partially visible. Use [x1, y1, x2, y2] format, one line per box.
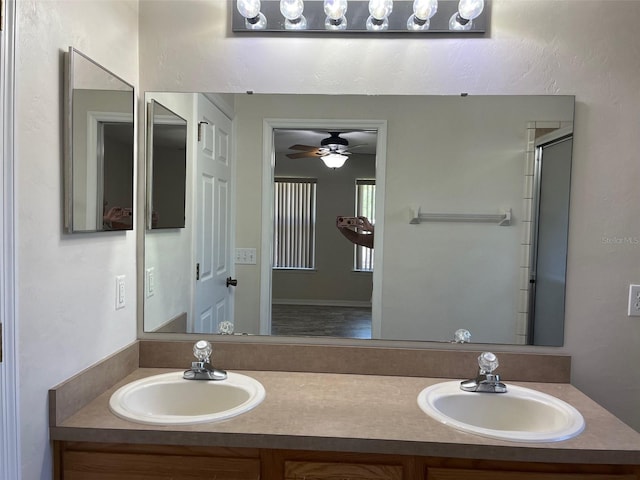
[271, 127, 377, 338]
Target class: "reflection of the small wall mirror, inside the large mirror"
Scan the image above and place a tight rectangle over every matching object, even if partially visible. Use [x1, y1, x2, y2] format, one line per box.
[147, 100, 187, 229]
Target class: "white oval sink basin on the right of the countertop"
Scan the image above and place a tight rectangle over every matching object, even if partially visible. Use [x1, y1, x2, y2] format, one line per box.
[418, 381, 584, 442]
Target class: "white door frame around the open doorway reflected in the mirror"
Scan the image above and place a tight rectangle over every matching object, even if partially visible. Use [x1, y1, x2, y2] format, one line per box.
[260, 118, 387, 339]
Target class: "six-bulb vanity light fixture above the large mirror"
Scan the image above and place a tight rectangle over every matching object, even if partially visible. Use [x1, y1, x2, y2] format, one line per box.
[231, 0, 490, 37]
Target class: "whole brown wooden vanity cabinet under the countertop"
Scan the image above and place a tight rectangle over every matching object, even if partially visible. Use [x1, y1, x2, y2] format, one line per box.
[54, 441, 640, 480]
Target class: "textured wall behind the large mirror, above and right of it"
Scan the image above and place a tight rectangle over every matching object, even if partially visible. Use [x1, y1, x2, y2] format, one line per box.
[140, 0, 640, 429]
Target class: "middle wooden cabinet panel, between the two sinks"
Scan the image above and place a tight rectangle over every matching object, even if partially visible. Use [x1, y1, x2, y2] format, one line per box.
[284, 461, 402, 480]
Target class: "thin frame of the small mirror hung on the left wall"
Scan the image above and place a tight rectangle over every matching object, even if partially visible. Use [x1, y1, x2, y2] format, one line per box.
[63, 46, 138, 234]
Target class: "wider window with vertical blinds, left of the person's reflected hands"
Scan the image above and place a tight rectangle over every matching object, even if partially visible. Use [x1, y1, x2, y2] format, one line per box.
[273, 178, 317, 270]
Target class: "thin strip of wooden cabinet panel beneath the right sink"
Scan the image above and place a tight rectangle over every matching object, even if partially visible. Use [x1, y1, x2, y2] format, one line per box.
[427, 468, 637, 480]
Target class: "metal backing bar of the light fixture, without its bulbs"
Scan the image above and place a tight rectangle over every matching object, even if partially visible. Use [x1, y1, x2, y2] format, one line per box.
[231, 0, 490, 36]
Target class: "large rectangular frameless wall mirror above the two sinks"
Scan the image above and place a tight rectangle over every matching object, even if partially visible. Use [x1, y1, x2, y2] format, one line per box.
[143, 92, 574, 346]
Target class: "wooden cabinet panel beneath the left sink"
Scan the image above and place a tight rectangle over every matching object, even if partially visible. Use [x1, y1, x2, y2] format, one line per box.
[62, 452, 260, 480]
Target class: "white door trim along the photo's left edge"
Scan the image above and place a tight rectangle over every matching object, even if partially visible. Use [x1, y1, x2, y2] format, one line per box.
[0, 0, 20, 478]
